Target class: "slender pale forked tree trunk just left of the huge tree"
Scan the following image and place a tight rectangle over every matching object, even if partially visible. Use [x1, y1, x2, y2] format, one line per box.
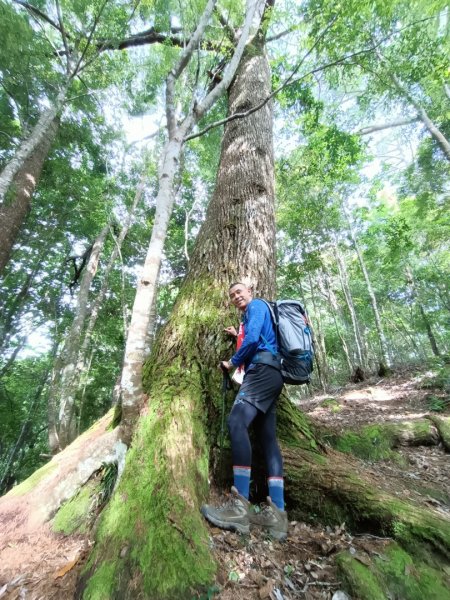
[121, 0, 264, 443]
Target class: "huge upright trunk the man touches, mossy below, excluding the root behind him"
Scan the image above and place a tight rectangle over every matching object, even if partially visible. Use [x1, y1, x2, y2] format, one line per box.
[80, 37, 275, 600]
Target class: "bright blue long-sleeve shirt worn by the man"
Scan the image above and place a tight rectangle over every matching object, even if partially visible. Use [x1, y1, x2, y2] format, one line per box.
[230, 298, 278, 369]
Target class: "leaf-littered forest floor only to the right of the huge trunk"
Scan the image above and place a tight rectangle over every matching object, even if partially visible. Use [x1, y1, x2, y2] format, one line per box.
[209, 372, 450, 600]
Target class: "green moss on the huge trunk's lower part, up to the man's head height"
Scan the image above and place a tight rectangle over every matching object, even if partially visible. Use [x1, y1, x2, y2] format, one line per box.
[80, 288, 229, 600]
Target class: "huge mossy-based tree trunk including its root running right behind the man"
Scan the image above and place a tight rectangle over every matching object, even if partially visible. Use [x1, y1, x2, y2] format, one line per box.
[77, 34, 450, 600]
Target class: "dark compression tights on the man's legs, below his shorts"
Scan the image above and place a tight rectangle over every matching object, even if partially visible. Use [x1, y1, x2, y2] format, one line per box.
[228, 401, 283, 477]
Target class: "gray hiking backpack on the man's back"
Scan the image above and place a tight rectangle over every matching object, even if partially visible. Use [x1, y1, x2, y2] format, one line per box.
[264, 300, 314, 385]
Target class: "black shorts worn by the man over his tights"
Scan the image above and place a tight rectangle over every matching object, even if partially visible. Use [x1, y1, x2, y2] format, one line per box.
[234, 364, 283, 413]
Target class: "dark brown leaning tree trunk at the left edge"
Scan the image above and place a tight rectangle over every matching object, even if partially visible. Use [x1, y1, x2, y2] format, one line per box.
[0, 116, 59, 273]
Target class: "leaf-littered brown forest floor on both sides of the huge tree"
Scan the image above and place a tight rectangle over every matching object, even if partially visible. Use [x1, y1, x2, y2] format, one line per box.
[0, 373, 450, 600]
